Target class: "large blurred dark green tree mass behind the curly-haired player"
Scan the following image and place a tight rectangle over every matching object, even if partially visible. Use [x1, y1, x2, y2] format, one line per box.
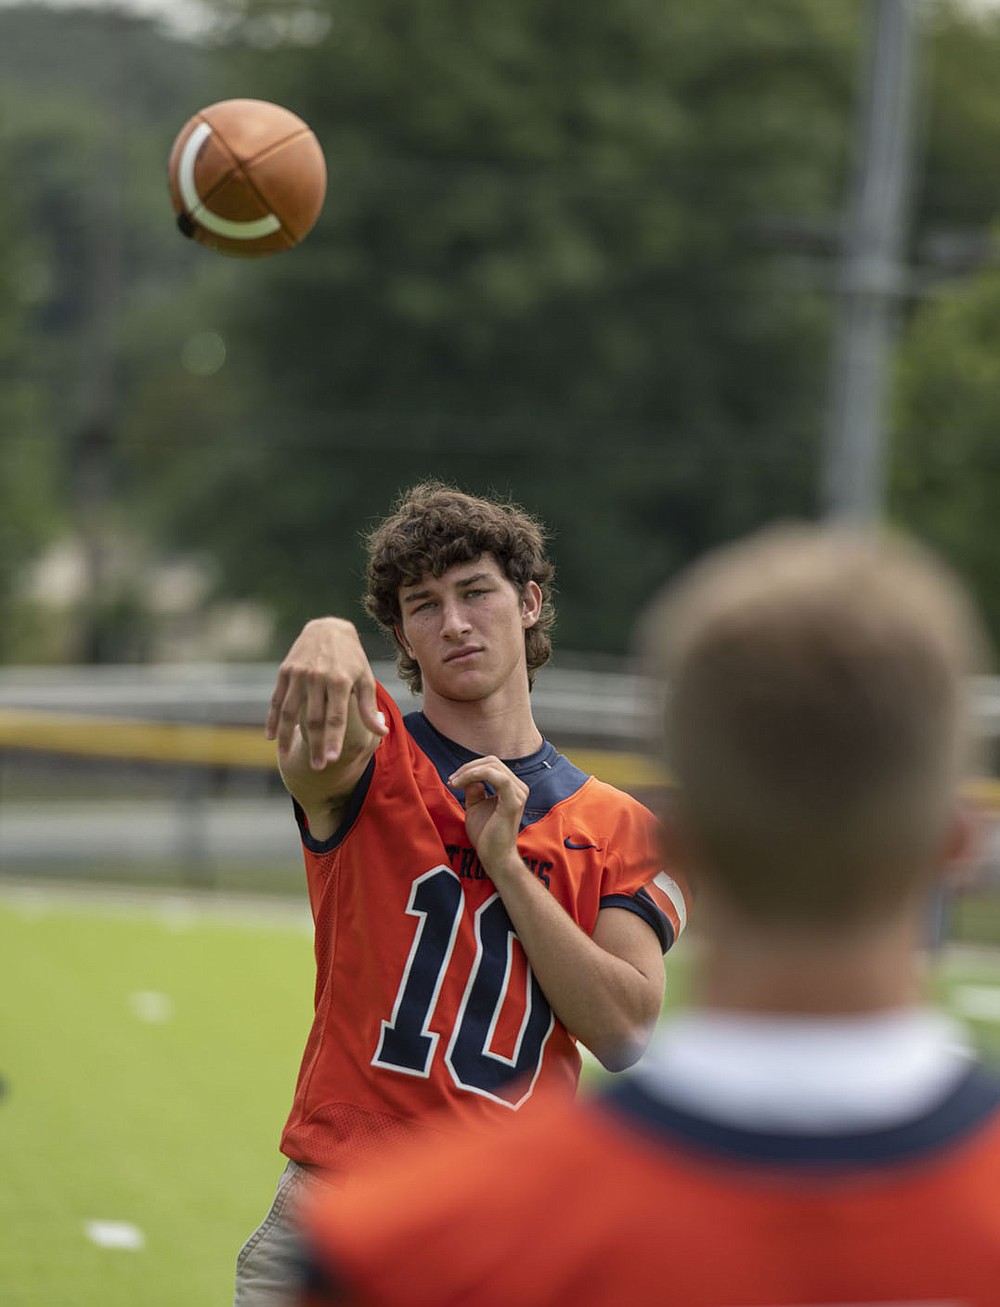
[129, 0, 859, 651]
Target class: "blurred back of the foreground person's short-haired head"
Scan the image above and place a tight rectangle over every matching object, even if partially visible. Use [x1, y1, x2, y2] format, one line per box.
[647, 527, 986, 932]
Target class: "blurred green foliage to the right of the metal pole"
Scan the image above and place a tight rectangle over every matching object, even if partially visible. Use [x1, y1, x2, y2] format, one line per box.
[889, 5, 1000, 639]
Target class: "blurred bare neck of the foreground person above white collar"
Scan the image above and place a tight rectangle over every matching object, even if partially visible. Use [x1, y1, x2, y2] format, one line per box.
[694, 918, 925, 1017]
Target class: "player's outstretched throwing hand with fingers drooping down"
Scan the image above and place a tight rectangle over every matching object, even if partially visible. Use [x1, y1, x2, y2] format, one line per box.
[267, 617, 388, 771]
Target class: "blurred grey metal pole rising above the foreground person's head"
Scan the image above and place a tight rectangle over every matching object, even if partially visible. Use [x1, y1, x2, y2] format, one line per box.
[824, 0, 920, 523]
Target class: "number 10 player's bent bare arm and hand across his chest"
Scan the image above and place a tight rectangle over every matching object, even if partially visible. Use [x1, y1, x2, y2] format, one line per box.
[450, 757, 664, 1070]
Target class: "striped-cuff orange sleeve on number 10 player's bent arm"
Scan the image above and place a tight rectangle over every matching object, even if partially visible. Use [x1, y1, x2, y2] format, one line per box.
[600, 800, 690, 953]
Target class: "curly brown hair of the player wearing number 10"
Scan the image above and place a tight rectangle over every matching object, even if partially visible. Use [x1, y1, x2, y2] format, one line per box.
[365, 481, 556, 694]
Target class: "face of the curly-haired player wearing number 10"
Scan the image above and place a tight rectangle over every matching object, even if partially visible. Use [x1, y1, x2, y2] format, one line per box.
[399, 554, 541, 701]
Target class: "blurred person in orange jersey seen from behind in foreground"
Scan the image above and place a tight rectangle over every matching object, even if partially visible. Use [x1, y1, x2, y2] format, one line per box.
[290, 527, 1000, 1307]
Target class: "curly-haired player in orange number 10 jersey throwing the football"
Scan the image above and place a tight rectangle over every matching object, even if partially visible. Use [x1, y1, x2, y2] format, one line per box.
[235, 482, 686, 1307]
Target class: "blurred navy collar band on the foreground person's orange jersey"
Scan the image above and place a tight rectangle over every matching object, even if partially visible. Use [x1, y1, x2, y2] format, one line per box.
[599, 1064, 1000, 1171]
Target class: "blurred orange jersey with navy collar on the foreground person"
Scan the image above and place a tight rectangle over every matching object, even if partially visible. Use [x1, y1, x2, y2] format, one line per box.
[302, 1050, 1000, 1307]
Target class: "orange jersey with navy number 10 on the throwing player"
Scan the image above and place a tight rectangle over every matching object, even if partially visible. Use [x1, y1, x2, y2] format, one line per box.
[281, 687, 686, 1168]
